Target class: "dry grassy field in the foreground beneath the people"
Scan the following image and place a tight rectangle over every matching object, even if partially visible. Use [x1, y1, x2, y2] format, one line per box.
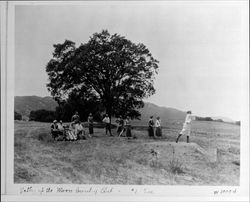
[14, 121, 240, 185]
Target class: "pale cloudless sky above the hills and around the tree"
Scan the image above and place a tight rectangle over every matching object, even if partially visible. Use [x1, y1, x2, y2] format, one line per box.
[15, 2, 248, 120]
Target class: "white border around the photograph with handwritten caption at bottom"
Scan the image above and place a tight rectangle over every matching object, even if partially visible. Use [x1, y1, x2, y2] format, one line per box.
[1, 1, 249, 201]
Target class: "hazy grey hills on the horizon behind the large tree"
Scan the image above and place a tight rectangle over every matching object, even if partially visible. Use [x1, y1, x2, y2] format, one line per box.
[15, 96, 185, 122]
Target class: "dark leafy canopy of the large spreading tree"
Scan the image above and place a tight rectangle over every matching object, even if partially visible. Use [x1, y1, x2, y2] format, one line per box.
[46, 30, 158, 118]
